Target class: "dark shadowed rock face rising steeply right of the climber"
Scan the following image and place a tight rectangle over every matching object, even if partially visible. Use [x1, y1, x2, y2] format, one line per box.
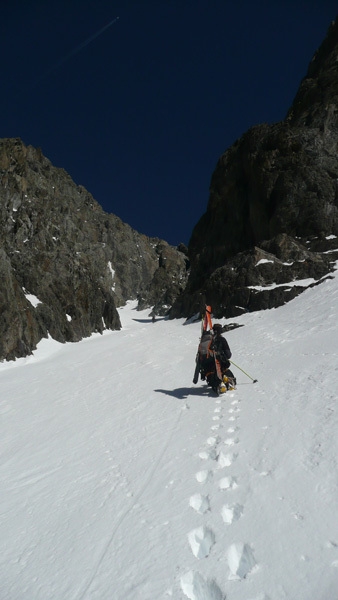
[170, 22, 338, 317]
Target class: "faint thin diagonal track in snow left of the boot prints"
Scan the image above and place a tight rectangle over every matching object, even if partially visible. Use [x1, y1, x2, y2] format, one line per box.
[74, 404, 187, 600]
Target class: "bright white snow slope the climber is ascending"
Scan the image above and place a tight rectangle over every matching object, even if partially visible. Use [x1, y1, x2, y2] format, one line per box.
[0, 270, 338, 600]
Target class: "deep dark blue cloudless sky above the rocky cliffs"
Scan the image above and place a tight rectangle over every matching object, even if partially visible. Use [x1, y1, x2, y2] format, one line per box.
[0, 0, 338, 245]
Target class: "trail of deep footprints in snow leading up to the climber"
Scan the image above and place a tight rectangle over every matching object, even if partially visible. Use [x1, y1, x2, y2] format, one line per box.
[180, 386, 264, 600]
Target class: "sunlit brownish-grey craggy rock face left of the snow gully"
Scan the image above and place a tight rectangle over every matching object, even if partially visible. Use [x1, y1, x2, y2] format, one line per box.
[0, 139, 188, 359]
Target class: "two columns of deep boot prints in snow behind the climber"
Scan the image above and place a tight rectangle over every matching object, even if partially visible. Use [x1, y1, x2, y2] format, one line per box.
[180, 393, 257, 600]
